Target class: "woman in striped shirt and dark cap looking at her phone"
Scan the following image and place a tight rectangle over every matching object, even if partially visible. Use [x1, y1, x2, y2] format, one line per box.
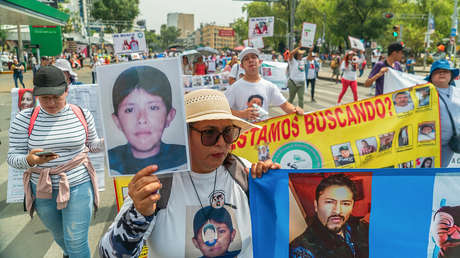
[8, 66, 103, 257]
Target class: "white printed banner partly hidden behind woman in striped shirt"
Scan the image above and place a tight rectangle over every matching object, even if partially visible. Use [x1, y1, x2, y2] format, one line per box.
[6, 84, 105, 203]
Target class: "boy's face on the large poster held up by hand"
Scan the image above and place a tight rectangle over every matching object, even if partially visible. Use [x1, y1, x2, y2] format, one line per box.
[112, 89, 176, 158]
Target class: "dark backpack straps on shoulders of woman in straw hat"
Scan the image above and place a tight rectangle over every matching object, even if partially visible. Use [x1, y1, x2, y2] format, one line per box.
[154, 154, 249, 216]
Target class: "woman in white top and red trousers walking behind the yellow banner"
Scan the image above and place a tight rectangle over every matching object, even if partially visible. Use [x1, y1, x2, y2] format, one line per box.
[337, 50, 359, 105]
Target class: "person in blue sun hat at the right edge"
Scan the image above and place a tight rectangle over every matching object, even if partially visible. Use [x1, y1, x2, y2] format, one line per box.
[425, 59, 460, 167]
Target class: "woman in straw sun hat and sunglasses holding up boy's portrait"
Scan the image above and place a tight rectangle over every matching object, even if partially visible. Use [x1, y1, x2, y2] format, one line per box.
[99, 89, 280, 257]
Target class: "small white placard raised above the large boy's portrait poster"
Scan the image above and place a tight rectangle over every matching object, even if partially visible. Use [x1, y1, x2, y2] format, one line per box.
[113, 32, 148, 55]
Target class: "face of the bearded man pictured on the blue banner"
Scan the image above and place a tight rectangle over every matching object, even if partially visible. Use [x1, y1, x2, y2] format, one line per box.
[315, 185, 354, 233]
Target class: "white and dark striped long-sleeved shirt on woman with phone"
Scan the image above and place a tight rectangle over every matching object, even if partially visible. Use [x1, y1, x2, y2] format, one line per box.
[8, 104, 103, 189]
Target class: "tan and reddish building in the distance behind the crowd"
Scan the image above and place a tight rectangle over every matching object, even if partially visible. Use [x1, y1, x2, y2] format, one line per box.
[202, 25, 237, 49]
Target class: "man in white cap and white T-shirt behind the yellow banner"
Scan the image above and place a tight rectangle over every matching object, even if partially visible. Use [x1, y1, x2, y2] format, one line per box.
[225, 47, 304, 121]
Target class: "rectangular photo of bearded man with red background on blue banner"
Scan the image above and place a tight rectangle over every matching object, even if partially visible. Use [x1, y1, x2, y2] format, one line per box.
[289, 173, 372, 258]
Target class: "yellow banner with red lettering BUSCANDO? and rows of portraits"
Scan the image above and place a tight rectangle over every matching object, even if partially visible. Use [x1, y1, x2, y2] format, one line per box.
[232, 84, 441, 169]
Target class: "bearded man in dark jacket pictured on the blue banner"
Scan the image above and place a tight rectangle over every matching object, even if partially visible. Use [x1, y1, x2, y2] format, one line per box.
[289, 174, 369, 258]
